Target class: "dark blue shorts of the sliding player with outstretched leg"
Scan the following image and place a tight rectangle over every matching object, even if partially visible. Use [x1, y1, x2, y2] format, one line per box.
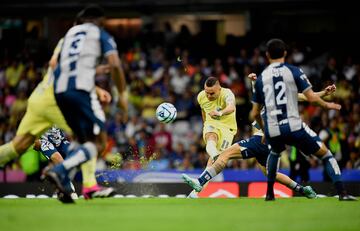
[237, 135, 270, 166]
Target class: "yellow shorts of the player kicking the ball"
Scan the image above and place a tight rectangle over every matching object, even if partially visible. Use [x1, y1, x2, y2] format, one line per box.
[203, 124, 236, 152]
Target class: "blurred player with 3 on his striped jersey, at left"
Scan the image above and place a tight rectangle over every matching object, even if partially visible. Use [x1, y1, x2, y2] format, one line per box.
[45, 5, 127, 202]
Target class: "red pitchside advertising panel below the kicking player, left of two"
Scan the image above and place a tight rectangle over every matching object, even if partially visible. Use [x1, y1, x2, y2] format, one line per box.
[199, 182, 240, 198]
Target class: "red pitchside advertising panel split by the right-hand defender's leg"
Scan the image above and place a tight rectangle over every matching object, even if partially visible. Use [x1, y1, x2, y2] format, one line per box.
[248, 182, 293, 197]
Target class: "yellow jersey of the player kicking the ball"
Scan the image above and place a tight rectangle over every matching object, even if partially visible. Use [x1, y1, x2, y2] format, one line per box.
[197, 88, 237, 134]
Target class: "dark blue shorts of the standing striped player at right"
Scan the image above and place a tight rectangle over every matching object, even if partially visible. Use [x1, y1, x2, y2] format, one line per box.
[267, 124, 322, 155]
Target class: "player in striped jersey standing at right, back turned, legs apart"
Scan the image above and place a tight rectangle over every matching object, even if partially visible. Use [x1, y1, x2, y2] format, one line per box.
[250, 39, 356, 201]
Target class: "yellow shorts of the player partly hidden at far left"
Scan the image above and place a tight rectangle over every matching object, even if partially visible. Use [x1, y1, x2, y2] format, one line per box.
[16, 90, 71, 137]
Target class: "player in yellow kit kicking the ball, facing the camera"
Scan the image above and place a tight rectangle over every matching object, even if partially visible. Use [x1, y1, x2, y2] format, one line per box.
[184, 77, 237, 197]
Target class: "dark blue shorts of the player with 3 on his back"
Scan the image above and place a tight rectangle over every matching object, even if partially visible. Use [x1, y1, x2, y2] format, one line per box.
[55, 90, 105, 143]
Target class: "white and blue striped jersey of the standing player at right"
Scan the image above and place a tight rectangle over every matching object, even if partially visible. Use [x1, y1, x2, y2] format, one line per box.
[252, 63, 312, 137]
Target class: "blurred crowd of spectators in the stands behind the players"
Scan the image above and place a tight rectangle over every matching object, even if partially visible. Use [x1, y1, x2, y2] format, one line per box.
[0, 22, 360, 179]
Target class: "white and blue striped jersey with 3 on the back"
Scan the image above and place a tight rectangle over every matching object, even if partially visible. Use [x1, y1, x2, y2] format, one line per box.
[54, 23, 117, 94]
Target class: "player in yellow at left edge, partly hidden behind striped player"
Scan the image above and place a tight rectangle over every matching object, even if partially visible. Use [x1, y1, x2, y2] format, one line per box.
[0, 40, 71, 166]
